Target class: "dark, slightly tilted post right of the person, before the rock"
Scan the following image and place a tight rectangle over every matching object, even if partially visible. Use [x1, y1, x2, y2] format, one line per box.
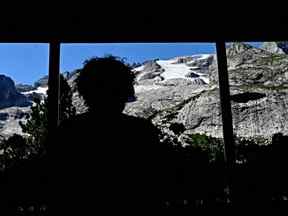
[216, 41, 235, 204]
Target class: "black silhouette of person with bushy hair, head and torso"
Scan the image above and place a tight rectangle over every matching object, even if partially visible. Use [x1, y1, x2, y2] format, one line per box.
[51, 56, 172, 215]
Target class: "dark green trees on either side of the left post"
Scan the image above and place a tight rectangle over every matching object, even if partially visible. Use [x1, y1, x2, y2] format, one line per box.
[0, 74, 76, 171]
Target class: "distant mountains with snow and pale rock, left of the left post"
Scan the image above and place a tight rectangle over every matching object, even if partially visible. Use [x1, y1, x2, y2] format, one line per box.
[0, 71, 76, 137]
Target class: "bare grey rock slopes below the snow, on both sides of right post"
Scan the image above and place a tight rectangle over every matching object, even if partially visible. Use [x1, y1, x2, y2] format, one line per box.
[126, 43, 288, 143]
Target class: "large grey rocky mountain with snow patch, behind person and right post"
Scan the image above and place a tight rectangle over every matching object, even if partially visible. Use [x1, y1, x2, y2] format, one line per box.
[0, 43, 288, 145]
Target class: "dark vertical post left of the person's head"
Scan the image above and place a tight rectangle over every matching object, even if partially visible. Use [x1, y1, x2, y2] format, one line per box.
[48, 41, 60, 149]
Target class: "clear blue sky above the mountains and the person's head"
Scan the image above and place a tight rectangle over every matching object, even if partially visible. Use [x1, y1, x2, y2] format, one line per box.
[0, 43, 260, 84]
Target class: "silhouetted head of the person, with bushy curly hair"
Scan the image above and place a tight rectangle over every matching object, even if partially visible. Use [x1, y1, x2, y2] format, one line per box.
[76, 56, 135, 112]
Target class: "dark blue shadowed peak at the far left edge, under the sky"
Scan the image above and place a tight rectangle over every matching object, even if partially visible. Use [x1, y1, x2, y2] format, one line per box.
[0, 75, 31, 109]
